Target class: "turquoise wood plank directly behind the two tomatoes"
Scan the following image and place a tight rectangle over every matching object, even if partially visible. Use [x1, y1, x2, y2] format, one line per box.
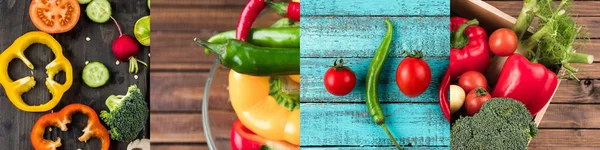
[300, 57, 449, 102]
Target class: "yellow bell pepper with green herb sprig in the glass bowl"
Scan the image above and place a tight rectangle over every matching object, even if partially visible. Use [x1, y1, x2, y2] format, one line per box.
[229, 70, 300, 145]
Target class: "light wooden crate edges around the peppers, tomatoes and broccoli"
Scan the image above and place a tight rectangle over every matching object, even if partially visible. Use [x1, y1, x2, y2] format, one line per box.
[450, 0, 564, 125]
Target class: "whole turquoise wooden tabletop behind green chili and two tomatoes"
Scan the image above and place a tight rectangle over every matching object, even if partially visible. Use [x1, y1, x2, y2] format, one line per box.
[300, 0, 450, 149]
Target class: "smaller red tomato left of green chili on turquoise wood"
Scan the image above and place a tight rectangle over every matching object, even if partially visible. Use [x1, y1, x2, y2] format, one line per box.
[323, 59, 356, 96]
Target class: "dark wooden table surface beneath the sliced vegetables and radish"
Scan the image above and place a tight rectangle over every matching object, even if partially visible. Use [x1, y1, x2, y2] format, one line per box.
[0, 0, 150, 150]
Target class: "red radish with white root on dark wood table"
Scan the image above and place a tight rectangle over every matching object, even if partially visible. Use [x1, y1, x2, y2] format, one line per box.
[110, 16, 148, 74]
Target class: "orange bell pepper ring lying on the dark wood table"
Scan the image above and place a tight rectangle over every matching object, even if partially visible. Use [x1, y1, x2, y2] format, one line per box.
[31, 104, 110, 150]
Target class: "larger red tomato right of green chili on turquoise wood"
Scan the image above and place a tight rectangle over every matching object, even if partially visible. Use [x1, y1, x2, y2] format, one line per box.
[396, 56, 431, 97]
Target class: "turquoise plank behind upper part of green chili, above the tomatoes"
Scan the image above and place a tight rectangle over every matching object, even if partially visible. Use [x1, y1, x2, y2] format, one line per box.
[300, 16, 450, 58]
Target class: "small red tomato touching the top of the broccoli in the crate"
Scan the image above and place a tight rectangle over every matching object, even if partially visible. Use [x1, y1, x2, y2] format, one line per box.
[465, 88, 492, 116]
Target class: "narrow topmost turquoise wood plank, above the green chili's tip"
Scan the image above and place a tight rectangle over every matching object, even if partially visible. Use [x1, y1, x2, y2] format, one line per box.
[300, 0, 450, 16]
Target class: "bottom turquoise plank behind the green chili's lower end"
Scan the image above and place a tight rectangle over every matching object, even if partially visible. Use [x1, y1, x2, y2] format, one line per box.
[300, 103, 450, 147]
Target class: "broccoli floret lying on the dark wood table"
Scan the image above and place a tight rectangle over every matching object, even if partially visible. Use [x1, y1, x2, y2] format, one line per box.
[100, 85, 149, 141]
